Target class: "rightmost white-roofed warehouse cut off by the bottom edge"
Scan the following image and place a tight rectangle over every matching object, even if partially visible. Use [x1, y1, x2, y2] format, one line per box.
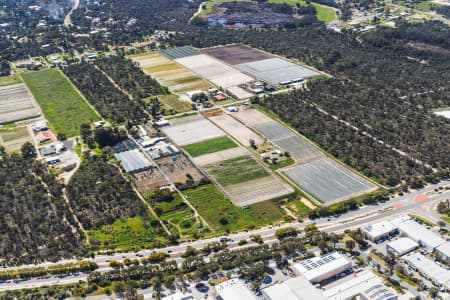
[323, 270, 398, 300]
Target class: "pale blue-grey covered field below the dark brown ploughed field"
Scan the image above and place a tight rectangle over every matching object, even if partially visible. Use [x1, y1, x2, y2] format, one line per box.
[237, 58, 320, 85]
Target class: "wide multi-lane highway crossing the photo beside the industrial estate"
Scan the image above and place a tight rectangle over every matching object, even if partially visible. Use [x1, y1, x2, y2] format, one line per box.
[0, 181, 450, 291]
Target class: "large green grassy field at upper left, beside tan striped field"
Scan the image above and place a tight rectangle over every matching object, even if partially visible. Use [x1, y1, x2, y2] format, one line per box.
[22, 69, 100, 137]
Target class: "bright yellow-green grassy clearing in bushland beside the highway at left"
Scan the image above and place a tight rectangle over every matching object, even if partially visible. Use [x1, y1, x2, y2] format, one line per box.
[89, 216, 166, 250]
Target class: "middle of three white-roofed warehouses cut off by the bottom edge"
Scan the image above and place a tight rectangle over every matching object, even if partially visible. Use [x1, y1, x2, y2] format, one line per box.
[262, 276, 325, 300]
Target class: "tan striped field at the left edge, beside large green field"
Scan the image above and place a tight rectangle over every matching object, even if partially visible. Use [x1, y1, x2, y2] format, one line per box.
[0, 83, 41, 124]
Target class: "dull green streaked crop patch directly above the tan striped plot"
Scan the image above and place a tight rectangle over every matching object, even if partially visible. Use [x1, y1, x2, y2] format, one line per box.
[205, 156, 269, 186]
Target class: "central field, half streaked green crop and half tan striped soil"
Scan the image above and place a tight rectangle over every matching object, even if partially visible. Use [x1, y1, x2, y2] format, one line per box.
[204, 155, 294, 206]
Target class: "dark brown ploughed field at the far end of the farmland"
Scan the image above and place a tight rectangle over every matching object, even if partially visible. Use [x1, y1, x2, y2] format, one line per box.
[202, 45, 273, 65]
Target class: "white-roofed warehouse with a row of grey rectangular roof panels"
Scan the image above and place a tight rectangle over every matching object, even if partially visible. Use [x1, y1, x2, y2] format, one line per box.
[294, 252, 352, 283]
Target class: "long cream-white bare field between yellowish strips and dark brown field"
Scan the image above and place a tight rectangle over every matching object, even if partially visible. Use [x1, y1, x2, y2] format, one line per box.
[175, 54, 253, 88]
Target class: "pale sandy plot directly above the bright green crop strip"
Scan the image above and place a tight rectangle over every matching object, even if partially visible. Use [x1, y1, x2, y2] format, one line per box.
[162, 115, 225, 146]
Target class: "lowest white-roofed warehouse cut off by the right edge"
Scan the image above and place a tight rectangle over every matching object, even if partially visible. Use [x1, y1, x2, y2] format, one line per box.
[404, 253, 450, 290]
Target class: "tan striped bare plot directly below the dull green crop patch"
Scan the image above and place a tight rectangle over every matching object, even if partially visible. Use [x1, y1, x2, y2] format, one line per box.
[224, 175, 294, 206]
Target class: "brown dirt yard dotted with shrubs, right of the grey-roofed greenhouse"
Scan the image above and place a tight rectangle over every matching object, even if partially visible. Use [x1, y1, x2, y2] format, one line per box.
[156, 155, 203, 183]
